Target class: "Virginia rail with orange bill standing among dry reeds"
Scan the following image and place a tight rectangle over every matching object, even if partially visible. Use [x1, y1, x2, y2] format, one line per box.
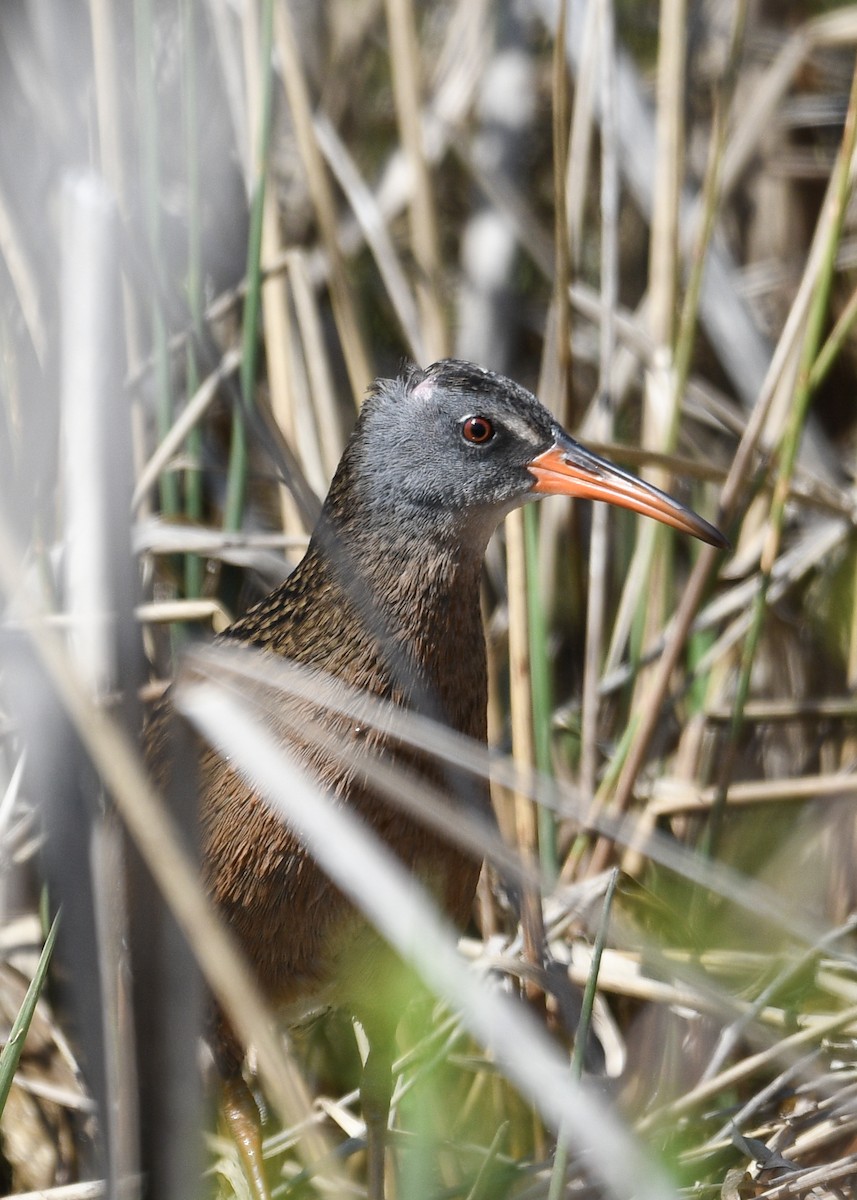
[180, 360, 726, 1196]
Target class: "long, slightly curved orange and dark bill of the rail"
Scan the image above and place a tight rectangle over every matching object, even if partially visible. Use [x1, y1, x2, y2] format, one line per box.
[527, 432, 729, 550]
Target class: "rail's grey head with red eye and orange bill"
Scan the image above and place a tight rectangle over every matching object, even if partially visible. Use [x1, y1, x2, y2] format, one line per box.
[329, 359, 727, 547]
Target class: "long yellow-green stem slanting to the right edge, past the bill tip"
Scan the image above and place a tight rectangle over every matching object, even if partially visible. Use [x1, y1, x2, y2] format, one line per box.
[702, 60, 857, 856]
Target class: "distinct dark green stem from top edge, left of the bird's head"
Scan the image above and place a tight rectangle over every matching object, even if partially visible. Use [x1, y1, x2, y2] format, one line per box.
[223, 0, 274, 532]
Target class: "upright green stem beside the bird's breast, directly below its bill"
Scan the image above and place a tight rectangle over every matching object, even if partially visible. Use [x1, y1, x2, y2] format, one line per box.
[523, 504, 557, 880]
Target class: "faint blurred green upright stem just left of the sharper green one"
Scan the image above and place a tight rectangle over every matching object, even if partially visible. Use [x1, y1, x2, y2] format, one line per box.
[181, 0, 203, 598]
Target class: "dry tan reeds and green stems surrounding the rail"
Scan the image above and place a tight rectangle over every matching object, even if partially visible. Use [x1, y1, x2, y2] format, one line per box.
[0, 0, 857, 1200]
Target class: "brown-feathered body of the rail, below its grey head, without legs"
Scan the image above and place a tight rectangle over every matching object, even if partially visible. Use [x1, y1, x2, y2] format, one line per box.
[202, 422, 490, 1051]
